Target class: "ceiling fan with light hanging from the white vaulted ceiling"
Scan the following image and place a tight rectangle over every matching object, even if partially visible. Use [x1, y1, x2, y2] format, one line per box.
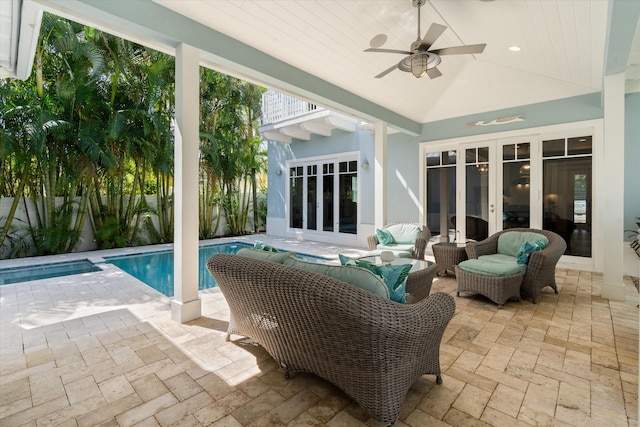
[364, 0, 487, 79]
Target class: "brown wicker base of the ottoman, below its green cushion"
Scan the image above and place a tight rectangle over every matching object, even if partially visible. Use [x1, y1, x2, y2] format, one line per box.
[455, 266, 524, 308]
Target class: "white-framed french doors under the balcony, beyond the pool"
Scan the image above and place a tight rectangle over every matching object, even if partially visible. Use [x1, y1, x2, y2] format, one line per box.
[288, 159, 358, 234]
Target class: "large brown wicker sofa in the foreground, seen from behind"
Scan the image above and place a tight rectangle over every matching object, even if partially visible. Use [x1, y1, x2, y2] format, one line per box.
[207, 254, 455, 425]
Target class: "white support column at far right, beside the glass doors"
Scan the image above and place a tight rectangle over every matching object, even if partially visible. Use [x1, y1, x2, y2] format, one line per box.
[601, 72, 625, 301]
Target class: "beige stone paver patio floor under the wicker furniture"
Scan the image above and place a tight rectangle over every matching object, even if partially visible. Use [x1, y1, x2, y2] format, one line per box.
[0, 241, 639, 427]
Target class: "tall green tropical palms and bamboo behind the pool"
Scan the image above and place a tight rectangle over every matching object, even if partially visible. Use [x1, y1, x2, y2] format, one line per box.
[0, 14, 266, 257]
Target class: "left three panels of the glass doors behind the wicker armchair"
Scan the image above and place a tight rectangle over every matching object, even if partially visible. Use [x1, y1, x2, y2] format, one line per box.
[426, 138, 535, 241]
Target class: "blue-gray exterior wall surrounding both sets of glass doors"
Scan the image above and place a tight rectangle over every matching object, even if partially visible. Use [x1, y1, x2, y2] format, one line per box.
[269, 92, 640, 240]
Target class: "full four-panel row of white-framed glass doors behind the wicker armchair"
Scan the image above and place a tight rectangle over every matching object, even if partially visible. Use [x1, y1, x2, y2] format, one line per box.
[425, 129, 593, 262]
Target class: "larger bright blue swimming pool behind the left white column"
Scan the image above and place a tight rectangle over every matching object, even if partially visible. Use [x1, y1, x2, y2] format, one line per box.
[104, 242, 328, 297]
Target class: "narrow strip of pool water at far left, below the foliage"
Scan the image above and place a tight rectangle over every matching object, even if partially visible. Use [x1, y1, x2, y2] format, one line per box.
[0, 259, 100, 285]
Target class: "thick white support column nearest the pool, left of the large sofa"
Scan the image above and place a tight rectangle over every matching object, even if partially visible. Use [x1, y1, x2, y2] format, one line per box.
[171, 43, 202, 323]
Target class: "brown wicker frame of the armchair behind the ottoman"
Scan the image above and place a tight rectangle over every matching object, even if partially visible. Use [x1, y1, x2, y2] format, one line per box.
[466, 228, 567, 304]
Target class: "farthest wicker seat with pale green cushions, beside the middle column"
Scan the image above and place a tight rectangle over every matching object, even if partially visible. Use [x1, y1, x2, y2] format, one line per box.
[367, 222, 431, 260]
